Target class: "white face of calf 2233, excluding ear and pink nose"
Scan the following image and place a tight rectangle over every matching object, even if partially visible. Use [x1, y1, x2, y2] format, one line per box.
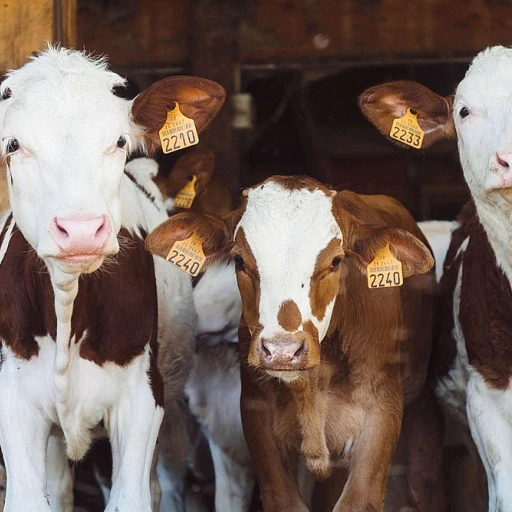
[453, 46, 512, 199]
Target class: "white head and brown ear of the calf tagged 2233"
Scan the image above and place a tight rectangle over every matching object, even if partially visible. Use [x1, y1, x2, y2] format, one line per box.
[359, 46, 512, 204]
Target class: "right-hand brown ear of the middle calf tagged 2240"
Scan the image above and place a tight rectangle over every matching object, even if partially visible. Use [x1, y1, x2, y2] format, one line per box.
[347, 226, 434, 279]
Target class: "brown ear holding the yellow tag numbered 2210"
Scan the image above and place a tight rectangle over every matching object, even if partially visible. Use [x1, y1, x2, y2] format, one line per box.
[132, 76, 226, 151]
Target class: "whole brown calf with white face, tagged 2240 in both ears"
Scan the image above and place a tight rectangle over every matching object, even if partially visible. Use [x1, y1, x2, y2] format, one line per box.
[146, 177, 442, 512]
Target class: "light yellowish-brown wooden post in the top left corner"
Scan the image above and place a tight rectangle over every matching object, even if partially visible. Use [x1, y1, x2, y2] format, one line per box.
[0, 0, 76, 213]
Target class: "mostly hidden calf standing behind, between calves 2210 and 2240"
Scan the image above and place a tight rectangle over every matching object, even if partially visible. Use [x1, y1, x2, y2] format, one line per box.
[154, 158, 255, 512]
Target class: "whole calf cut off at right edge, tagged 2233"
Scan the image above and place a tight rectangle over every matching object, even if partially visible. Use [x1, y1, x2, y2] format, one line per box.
[360, 46, 512, 512]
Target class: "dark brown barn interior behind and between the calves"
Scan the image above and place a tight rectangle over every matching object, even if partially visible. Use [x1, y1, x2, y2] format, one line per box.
[0, 0, 512, 512]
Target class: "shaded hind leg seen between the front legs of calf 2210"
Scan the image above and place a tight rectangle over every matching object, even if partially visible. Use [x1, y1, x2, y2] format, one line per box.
[46, 435, 73, 512]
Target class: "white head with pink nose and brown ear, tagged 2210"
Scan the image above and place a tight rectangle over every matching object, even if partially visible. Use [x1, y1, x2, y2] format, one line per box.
[0, 47, 224, 274]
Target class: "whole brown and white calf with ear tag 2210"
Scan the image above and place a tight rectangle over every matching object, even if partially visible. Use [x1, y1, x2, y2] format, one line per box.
[0, 48, 224, 512]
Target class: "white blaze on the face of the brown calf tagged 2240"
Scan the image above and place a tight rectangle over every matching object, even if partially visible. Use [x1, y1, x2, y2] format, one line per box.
[235, 181, 343, 341]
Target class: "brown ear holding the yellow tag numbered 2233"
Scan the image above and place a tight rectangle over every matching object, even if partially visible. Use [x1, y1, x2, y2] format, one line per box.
[359, 80, 456, 147]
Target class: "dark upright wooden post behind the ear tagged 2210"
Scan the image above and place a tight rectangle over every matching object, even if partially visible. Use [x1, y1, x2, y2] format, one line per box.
[191, 0, 245, 214]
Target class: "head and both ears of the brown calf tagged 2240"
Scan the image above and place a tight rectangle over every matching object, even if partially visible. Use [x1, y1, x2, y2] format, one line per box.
[146, 176, 433, 380]
